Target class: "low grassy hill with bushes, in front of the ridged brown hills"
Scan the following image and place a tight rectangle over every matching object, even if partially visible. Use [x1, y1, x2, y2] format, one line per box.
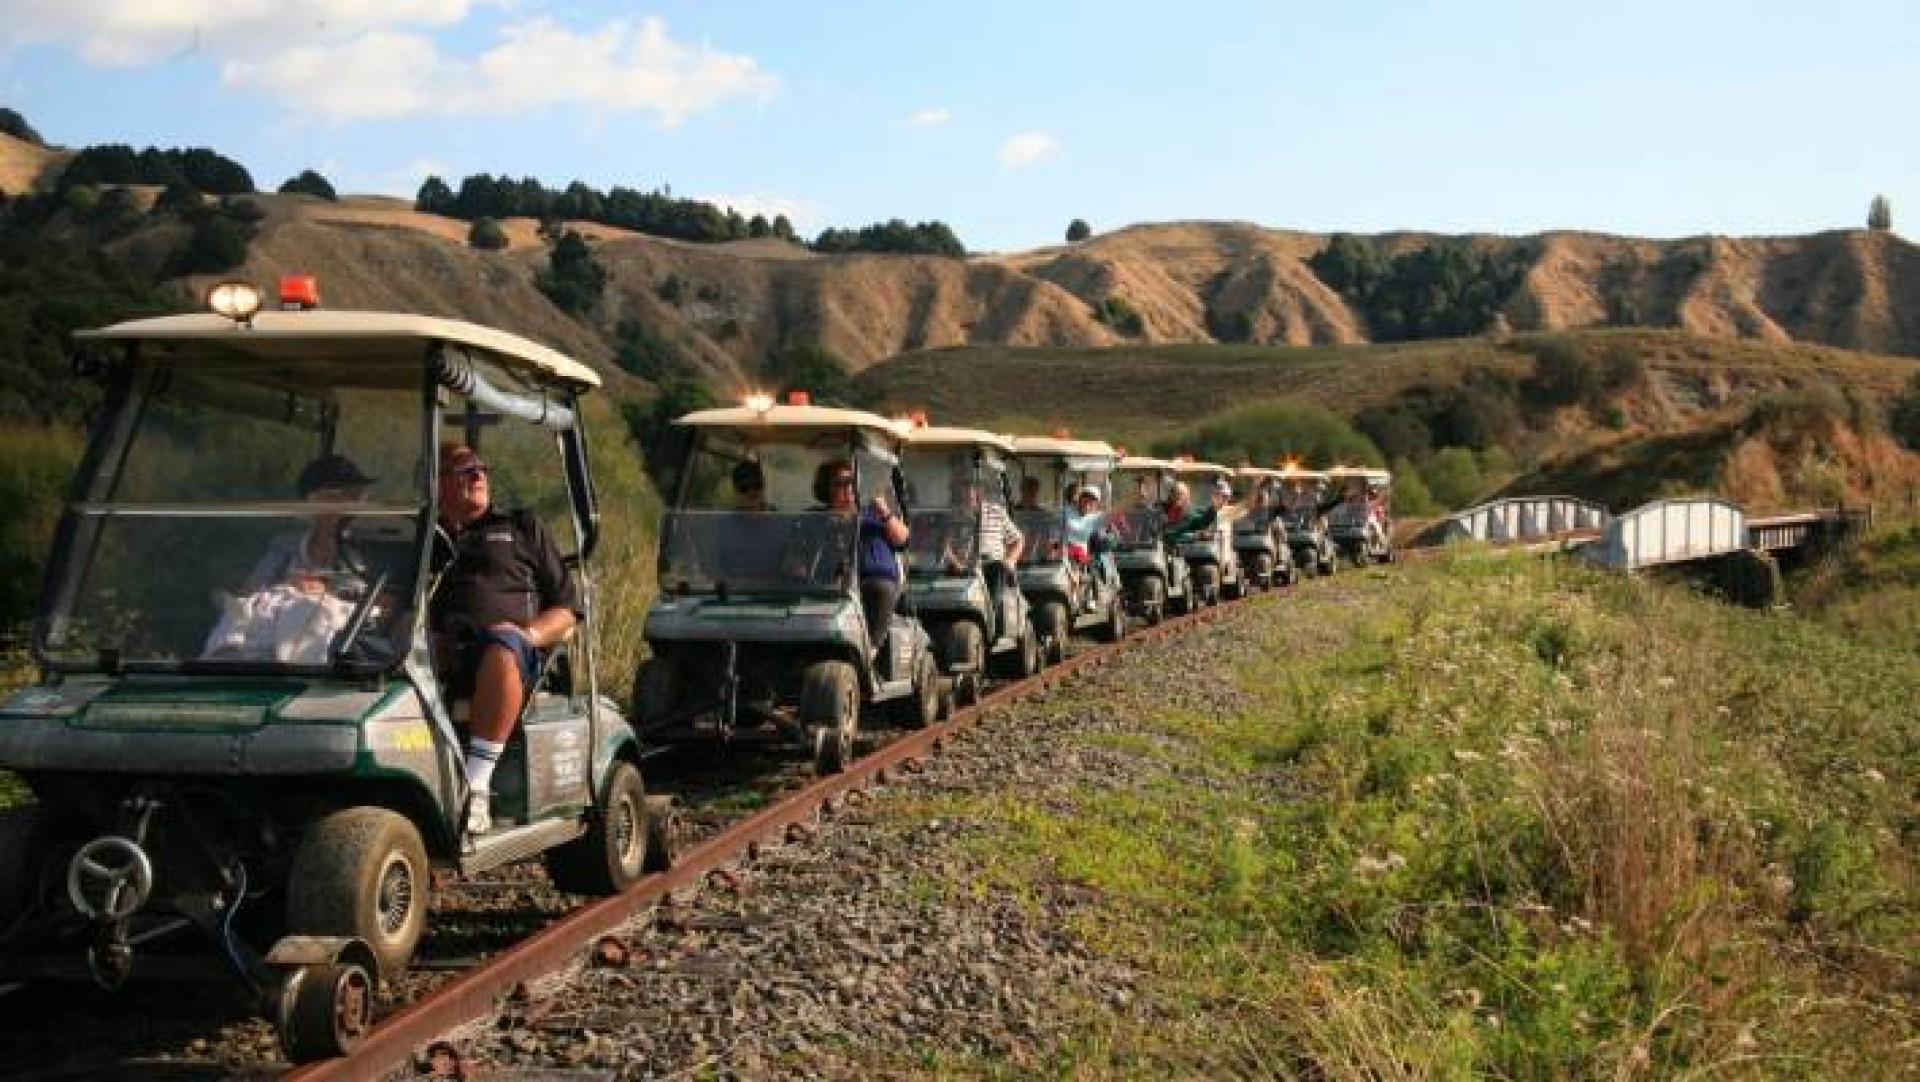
[856, 330, 1920, 508]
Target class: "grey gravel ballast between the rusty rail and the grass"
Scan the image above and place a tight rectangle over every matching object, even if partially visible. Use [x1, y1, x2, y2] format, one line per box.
[420, 602, 1284, 1078]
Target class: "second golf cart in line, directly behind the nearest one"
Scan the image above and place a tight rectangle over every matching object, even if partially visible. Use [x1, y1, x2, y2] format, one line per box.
[634, 393, 941, 773]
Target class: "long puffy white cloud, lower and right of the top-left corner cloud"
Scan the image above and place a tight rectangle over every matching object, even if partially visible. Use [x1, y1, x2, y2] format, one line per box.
[225, 17, 780, 127]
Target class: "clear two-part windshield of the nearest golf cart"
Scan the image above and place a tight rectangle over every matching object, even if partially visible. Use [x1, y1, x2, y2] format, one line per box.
[36, 355, 428, 671]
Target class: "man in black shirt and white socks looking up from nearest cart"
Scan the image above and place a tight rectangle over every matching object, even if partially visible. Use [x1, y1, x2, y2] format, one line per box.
[428, 443, 582, 835]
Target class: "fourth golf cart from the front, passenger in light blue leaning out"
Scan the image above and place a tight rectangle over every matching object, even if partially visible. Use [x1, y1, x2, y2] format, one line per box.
[1014, 435, 1127, 664]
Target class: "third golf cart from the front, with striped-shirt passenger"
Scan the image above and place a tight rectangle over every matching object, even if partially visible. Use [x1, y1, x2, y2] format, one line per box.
[900, 426, 1041, 706]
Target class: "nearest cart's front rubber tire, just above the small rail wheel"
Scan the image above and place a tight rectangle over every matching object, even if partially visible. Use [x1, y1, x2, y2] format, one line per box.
[286, 808, 432, 980]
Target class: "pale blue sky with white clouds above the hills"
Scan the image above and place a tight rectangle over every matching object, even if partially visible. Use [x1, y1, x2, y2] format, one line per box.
[0, 0, 1920, 249]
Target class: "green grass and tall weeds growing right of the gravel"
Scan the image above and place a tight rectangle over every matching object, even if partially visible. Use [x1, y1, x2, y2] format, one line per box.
[871, 560, 1920, 1078]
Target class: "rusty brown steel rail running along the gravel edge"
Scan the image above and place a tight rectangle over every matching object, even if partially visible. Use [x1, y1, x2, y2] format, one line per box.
[286, 595, 1252, 1082]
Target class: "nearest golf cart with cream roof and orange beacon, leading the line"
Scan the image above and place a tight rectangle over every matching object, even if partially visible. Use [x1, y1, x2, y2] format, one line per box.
[0, 278, 649, 1061]
